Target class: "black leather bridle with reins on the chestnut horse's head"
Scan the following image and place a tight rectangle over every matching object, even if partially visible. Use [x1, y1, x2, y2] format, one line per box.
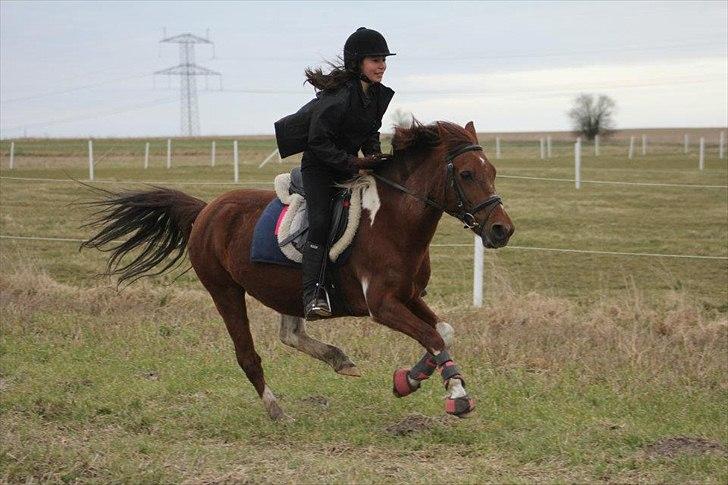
[372, 143, 503, 237]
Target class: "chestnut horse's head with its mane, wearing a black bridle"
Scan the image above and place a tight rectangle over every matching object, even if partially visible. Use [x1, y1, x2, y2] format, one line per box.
[392, 121, 514, 248]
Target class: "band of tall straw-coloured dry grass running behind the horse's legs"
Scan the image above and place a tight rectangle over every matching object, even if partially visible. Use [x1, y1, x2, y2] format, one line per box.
[0, 263, 728, 389]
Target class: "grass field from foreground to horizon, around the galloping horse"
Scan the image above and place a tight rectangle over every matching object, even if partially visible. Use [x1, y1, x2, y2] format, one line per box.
[0, 133, 728, 483]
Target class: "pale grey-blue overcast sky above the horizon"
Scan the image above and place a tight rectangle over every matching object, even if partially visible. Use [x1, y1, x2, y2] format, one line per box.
[0, 0, 728, 138]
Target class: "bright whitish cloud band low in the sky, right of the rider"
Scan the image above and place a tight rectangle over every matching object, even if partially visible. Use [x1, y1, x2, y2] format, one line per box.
[384, 57, 728, 131]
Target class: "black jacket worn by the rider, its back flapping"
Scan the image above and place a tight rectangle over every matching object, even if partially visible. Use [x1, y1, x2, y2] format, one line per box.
[275, 79, 394, 173]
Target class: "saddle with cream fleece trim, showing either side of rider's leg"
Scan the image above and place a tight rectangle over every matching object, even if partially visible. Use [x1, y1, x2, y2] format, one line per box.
[274, 167, 373, 263]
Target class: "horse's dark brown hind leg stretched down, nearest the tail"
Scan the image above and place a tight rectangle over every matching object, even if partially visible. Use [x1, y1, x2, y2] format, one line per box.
[206, 284, 286, 420]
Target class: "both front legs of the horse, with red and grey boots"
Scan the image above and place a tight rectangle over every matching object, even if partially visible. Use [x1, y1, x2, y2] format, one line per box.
[367, 290, 475, 416]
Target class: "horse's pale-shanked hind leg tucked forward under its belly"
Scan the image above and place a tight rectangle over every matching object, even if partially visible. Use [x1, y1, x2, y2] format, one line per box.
[280, 315, 361, 377]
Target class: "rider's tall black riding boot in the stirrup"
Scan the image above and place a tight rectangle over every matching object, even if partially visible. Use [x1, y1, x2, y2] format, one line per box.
[302, 242, 331, 320]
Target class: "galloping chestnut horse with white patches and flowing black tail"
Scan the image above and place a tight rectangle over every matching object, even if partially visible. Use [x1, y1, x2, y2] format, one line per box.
[82, 121, 513, 420]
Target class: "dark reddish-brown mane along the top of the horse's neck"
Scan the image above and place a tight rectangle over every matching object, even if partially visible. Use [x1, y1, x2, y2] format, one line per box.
[392, 118, 472, 158]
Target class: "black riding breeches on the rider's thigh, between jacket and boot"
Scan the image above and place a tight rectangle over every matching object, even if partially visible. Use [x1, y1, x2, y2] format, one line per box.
[301, 164, 341, 245]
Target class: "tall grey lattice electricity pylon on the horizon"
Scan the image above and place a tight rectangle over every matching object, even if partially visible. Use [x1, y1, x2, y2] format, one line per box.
[154, 33, 220, 136]
